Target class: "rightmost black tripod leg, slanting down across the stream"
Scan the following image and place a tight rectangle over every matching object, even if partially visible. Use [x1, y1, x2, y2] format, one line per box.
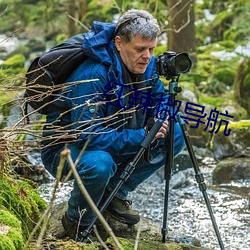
[177, 112, 225, 250]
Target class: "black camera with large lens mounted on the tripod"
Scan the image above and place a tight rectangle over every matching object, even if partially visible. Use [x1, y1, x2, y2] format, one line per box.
[156, 51, 192, 80]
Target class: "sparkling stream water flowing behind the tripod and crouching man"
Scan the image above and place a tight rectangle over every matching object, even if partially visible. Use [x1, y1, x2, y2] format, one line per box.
[39, 157, 250, 250]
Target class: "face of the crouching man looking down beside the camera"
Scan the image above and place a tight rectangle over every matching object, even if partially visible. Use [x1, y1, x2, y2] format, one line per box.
[115, 35, 157, 74]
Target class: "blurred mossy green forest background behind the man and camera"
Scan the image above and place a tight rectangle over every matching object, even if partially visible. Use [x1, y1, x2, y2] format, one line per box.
[0, 0, 250, 127]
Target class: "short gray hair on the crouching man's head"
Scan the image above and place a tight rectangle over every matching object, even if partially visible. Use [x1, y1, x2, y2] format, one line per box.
[116, 10, 160, 43]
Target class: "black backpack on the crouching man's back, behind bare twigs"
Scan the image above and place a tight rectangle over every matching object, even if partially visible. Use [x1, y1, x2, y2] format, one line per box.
[24, 34, 86, 115]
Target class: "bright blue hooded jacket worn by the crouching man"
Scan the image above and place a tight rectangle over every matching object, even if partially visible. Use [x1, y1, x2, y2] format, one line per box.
[44, 22, 168, 155]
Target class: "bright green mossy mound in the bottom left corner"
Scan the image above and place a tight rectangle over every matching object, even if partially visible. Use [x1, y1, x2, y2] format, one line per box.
[0, 209, 24, 250]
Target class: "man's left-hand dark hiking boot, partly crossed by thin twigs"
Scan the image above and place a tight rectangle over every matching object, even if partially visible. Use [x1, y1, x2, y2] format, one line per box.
[62, 213, 97, 243]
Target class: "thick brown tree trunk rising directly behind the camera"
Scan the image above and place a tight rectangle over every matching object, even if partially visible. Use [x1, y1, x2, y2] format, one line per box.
[167, 0, 196, 61]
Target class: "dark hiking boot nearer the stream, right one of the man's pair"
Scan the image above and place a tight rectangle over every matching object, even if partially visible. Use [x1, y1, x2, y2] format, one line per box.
[105, 197, 140, 225]
